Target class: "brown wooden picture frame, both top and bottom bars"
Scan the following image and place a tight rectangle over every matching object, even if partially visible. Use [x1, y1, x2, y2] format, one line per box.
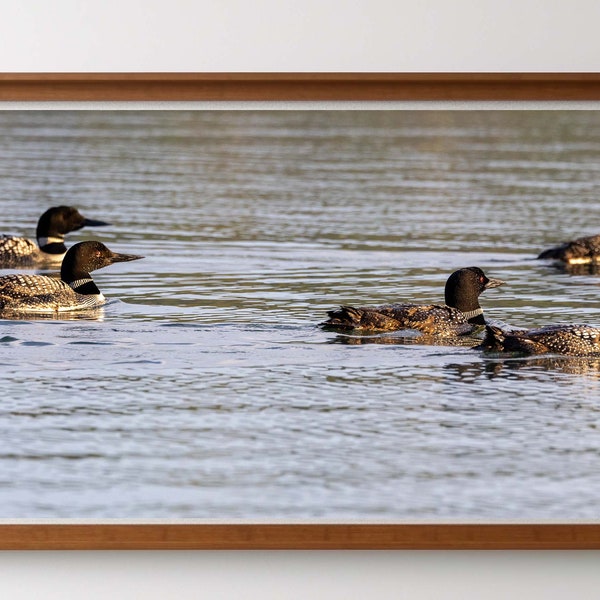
[0, 73, 600, 550]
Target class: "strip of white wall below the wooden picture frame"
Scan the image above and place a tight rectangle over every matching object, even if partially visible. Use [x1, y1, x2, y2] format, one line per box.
[0, 551, 600, 600]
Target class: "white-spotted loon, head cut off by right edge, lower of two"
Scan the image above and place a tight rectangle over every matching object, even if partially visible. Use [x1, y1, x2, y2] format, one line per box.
[477, 325, 600, 356]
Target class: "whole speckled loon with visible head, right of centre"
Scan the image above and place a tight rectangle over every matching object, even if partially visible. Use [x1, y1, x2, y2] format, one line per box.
[321, 267, 505, 337]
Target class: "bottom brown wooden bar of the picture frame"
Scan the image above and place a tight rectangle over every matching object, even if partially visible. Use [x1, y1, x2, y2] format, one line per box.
[0, 523, 600, 550]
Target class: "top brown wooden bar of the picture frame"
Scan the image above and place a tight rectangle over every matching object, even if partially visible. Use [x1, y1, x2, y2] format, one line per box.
[0, 73, 600, 102]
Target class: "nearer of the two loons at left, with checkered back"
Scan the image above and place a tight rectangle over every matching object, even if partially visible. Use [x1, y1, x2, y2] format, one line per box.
[0, 242, 143, 314]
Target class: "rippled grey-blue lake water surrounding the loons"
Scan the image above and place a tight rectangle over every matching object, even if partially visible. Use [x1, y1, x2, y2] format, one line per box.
[0, 110, 600, 521]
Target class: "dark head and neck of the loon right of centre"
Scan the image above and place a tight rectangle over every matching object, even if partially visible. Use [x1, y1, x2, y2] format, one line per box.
[445, 267, 505, 325]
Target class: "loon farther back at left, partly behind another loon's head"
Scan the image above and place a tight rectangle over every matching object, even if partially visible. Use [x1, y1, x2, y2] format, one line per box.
[0, 206, 108, 268]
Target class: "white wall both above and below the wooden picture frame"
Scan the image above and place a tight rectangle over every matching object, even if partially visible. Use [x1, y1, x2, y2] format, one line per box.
[0, 0, 600, 600]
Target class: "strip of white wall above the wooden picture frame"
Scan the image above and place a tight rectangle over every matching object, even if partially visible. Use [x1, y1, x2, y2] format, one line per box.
[0, 0, 600, 71]
